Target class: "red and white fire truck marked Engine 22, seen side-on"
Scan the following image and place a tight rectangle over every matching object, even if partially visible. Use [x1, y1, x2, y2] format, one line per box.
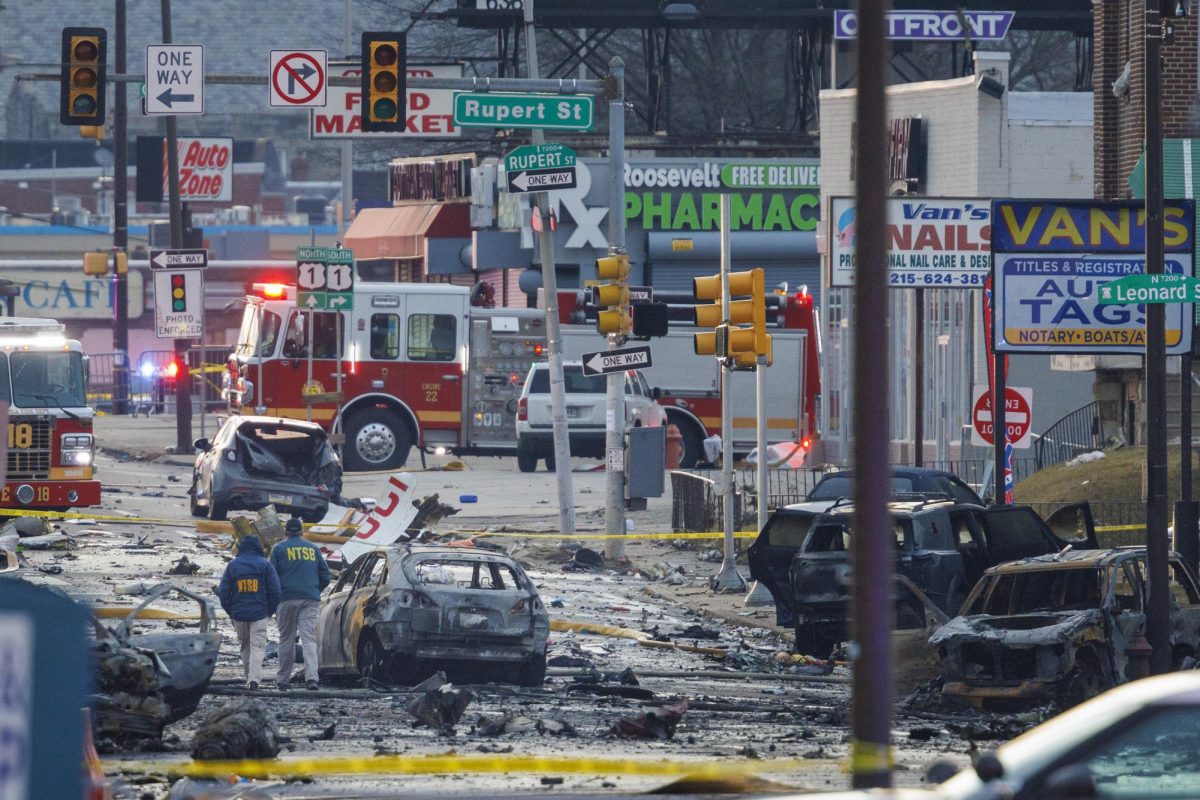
[223, 282, 821, 470]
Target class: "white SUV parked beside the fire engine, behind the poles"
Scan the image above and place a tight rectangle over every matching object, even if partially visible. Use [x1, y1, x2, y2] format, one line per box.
[516, 361, 666, 473]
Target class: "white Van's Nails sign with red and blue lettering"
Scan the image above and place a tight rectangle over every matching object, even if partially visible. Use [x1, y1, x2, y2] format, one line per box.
[827, 197, 991, 289]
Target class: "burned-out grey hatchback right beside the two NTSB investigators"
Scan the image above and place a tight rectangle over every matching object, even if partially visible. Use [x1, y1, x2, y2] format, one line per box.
[317, 545, 550, 686]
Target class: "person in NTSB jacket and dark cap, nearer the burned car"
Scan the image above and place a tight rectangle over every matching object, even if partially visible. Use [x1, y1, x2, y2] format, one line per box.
[271, 517, 329, 692]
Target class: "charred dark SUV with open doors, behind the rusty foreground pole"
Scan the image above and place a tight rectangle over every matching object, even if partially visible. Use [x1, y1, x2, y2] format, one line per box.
[790, 497, 1096, 657]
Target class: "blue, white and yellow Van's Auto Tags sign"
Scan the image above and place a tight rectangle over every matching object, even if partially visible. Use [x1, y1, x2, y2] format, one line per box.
[992, 200, 1195, 355]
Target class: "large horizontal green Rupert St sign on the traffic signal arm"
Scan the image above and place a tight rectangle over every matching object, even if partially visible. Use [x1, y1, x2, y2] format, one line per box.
[454, 92, 595, 131]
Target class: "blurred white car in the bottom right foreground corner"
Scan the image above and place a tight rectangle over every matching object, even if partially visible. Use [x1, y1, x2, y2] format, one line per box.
[779, 670, 1200, 800]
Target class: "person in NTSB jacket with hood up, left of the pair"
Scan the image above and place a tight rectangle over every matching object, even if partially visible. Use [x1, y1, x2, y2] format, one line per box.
[217, 536, 280, 690]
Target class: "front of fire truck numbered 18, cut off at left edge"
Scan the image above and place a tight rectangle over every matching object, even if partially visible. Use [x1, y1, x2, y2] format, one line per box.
[0, 317, 100, 516]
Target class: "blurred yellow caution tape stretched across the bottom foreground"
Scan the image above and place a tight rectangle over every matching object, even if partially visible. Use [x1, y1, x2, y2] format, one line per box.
[145, 754, 841, 780]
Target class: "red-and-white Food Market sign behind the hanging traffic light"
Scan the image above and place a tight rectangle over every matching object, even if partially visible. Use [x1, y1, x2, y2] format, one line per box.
[310, 65, 462, 139]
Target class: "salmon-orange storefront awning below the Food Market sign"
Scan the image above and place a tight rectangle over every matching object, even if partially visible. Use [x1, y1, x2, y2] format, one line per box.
[346, 203, 470, 261]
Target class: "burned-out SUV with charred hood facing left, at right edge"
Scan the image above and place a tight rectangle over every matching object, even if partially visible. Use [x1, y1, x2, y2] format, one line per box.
[930, 547, 1200, 705]
